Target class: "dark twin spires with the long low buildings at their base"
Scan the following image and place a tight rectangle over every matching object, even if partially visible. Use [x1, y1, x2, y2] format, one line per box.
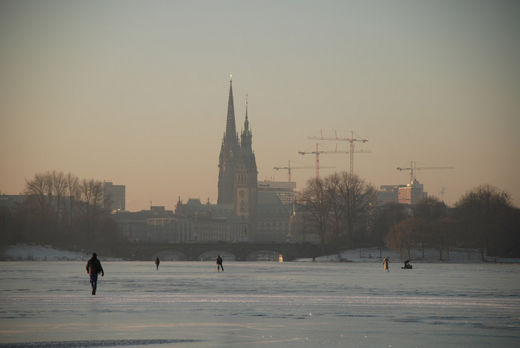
[115, 79, 294, 243]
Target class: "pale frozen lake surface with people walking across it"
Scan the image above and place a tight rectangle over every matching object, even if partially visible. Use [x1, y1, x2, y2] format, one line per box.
[0, 258, 520, 347]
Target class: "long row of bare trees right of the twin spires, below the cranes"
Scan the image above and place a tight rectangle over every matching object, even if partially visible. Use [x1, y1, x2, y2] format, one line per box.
[298, 173, 520, 260]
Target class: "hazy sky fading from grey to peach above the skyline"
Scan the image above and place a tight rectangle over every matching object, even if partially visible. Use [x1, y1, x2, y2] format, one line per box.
[0, 0, 520, 210]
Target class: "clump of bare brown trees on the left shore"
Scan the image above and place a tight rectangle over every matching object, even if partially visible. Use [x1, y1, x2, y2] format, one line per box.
[0, 171, 121, 250]
